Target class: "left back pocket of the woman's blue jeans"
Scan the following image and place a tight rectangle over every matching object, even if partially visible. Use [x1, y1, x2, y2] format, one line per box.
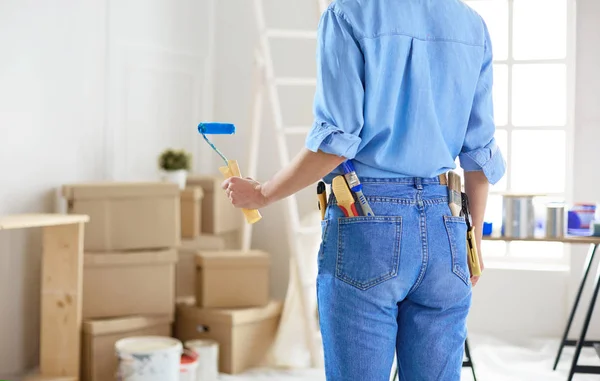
[336, 216, 402, 290]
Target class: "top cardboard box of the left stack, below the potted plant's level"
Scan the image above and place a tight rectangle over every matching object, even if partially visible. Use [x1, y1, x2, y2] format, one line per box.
[63, 182, 181, 252]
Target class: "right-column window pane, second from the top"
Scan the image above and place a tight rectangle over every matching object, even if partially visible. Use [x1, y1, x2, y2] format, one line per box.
[512, 64, 567, 126]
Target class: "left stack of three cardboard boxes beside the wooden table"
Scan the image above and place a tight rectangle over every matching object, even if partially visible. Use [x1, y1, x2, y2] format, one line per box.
[63, 182, 181, 381]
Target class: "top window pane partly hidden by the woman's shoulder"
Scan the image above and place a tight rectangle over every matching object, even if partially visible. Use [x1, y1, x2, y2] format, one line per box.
[465, 0, 508, 60]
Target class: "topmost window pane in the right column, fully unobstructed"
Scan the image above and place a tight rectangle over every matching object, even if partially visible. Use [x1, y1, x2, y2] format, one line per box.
[513, 0, 567, 59]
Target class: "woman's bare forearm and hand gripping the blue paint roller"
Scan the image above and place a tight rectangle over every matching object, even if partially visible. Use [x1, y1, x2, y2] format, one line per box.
[222, 148, 346, 209]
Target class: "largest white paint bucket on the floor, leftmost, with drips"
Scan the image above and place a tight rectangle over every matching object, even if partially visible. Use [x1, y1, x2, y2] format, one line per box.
[115, 336, 183, 381]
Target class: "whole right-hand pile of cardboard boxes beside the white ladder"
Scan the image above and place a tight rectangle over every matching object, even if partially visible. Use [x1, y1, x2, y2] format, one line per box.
[175, 176, 282, 374]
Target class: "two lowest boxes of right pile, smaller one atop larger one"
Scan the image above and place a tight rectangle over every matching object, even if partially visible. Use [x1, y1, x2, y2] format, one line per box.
[175, 250, 282, 374]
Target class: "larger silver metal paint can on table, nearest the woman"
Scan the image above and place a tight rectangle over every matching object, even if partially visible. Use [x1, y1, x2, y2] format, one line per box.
[502, 195, 535, 238]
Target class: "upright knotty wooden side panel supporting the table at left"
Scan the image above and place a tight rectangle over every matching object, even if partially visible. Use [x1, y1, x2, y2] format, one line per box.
[40, 222, 84, 378]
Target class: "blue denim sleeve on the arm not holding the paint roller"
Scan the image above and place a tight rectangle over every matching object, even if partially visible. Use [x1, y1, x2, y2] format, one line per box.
[459, 23, 506, 184]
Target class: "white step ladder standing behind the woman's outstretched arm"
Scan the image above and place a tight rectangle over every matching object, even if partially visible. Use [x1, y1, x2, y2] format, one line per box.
[242, 0, 329, 367]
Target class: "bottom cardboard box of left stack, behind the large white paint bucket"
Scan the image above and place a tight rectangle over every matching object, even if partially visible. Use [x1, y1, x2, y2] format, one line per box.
[81, 316, 172, 381]
